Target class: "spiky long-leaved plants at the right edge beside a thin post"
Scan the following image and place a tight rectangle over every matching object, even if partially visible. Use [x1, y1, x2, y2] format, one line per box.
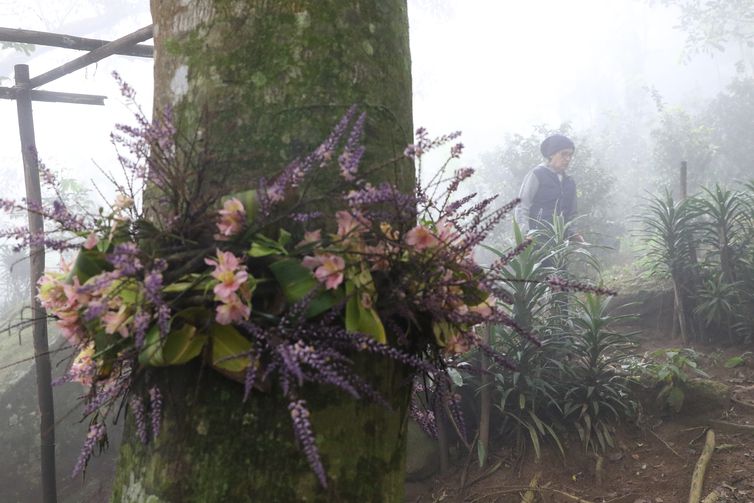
[642, 182, 754, 340]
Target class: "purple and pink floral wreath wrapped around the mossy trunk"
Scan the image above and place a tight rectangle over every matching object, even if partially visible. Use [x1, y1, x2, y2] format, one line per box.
[2, 79, 567, 486]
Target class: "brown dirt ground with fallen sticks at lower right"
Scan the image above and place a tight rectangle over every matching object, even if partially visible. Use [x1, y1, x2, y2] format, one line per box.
[406, 332, 754, 503]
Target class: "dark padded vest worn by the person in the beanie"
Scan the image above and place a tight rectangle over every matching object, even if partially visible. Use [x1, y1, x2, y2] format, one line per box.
[529, 165, 576, 228]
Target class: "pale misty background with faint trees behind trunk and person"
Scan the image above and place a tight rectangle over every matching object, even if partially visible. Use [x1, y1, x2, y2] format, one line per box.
[0, 0, 754, 500]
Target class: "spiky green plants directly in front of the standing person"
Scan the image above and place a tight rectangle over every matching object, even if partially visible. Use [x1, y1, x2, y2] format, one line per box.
[466, 224, 635, 457]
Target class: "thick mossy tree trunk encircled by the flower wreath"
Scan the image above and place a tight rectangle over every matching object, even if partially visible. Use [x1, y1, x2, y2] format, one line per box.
[112, 0, 414, 503]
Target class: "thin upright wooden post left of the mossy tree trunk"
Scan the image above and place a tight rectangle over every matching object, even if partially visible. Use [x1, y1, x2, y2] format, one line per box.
[15, 65, 57, 503]
